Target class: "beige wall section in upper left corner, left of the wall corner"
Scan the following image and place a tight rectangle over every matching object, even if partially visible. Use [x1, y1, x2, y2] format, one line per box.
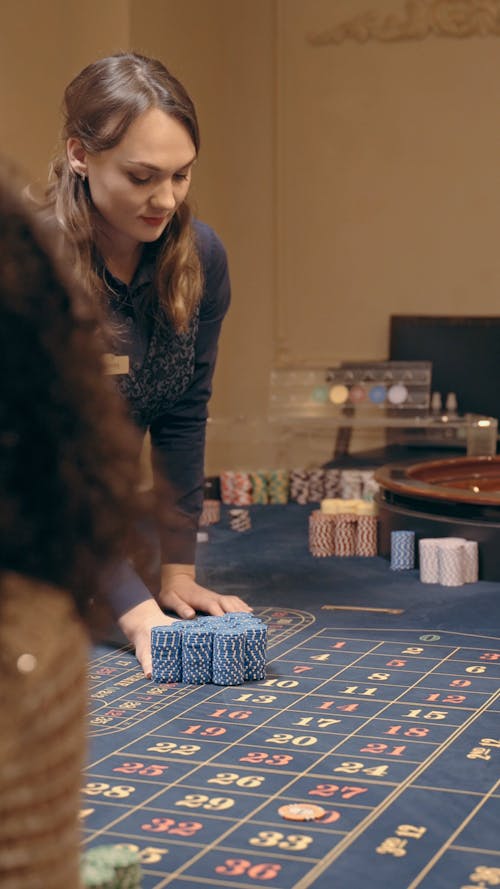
[0, 0, 129, 182]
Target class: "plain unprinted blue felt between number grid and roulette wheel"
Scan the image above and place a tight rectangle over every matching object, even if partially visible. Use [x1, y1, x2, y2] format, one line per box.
[193, 504, 500, 635]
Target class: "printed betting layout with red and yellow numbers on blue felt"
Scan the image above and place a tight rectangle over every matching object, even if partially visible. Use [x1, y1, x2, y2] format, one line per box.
[83, 610, 500, 889]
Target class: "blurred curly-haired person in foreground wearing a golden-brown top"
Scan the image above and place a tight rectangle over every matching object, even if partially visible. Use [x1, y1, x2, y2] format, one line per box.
[0, 168, 145, 889]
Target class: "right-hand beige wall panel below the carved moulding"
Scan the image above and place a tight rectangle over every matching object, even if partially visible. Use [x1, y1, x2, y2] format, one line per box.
[278, 0, 500, 365]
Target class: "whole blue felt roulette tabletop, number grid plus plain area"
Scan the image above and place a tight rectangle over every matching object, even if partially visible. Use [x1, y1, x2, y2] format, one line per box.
[81, 504, 500, 889]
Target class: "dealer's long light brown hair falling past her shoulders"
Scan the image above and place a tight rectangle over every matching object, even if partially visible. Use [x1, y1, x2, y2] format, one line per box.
[47, 53, 202, 330]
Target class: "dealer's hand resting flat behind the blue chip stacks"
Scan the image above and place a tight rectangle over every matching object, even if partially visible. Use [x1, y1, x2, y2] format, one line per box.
[158, 565, 252, 619]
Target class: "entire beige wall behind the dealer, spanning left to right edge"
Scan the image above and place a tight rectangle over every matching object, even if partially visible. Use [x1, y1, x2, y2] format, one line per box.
[0, 0, 500, 469]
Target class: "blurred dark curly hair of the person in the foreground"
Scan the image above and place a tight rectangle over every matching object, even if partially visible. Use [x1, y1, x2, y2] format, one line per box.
[0, 161, 145, 614]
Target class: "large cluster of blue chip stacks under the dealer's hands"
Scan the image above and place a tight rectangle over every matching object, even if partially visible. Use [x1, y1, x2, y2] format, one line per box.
[151, 612, 267, 685]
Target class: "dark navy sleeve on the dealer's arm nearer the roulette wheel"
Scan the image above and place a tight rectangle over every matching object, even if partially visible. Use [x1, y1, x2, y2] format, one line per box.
[150, 222, 230, 564]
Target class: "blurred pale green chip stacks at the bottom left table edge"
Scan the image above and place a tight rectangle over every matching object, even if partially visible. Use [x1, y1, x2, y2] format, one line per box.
[80, 846, 141, 889]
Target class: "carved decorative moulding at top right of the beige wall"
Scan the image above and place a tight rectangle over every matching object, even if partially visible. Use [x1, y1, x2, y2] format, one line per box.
[307, 0, 500, 46]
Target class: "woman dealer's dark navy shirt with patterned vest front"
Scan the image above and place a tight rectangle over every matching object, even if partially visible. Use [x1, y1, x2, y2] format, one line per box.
[105, 221, 230, 564]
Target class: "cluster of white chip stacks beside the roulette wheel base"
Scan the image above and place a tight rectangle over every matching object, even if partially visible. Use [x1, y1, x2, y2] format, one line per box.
[418, 537, 478, 586]
